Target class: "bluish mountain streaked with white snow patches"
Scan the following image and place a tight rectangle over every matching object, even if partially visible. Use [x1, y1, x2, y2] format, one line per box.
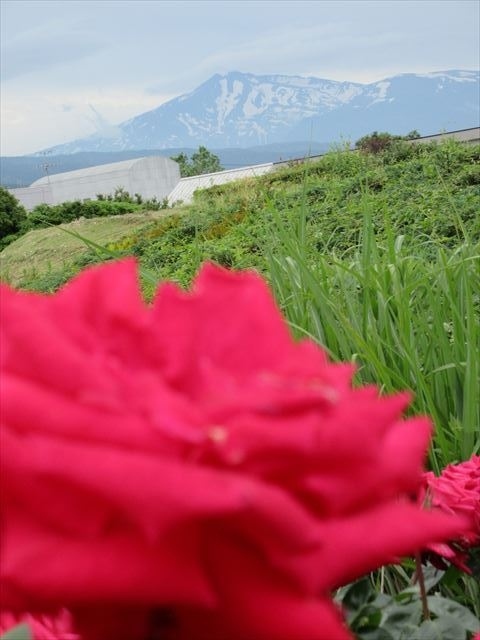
[37, 70, 480, 154]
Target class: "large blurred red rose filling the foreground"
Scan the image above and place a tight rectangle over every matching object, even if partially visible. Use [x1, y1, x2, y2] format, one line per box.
[0, 260, 464, 640]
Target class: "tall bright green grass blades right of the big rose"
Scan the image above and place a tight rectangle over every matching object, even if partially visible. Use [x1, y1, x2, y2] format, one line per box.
[267, 198, 480, 472]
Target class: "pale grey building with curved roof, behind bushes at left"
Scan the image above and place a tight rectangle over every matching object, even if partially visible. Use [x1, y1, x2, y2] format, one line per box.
[10, 156, 180, 210]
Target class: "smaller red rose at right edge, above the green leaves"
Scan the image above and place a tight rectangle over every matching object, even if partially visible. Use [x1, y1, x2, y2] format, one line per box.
[421, 455, 480, 573]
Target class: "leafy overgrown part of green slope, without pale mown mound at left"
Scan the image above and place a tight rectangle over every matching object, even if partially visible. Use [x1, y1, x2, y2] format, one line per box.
[128, 139, 480, 285]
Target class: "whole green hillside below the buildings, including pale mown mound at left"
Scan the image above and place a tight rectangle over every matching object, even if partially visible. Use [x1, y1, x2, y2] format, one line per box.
[0, 141, 480, 290]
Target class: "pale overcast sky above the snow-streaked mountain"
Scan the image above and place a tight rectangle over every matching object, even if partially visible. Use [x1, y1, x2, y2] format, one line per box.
[0, 0, 480, 155]
